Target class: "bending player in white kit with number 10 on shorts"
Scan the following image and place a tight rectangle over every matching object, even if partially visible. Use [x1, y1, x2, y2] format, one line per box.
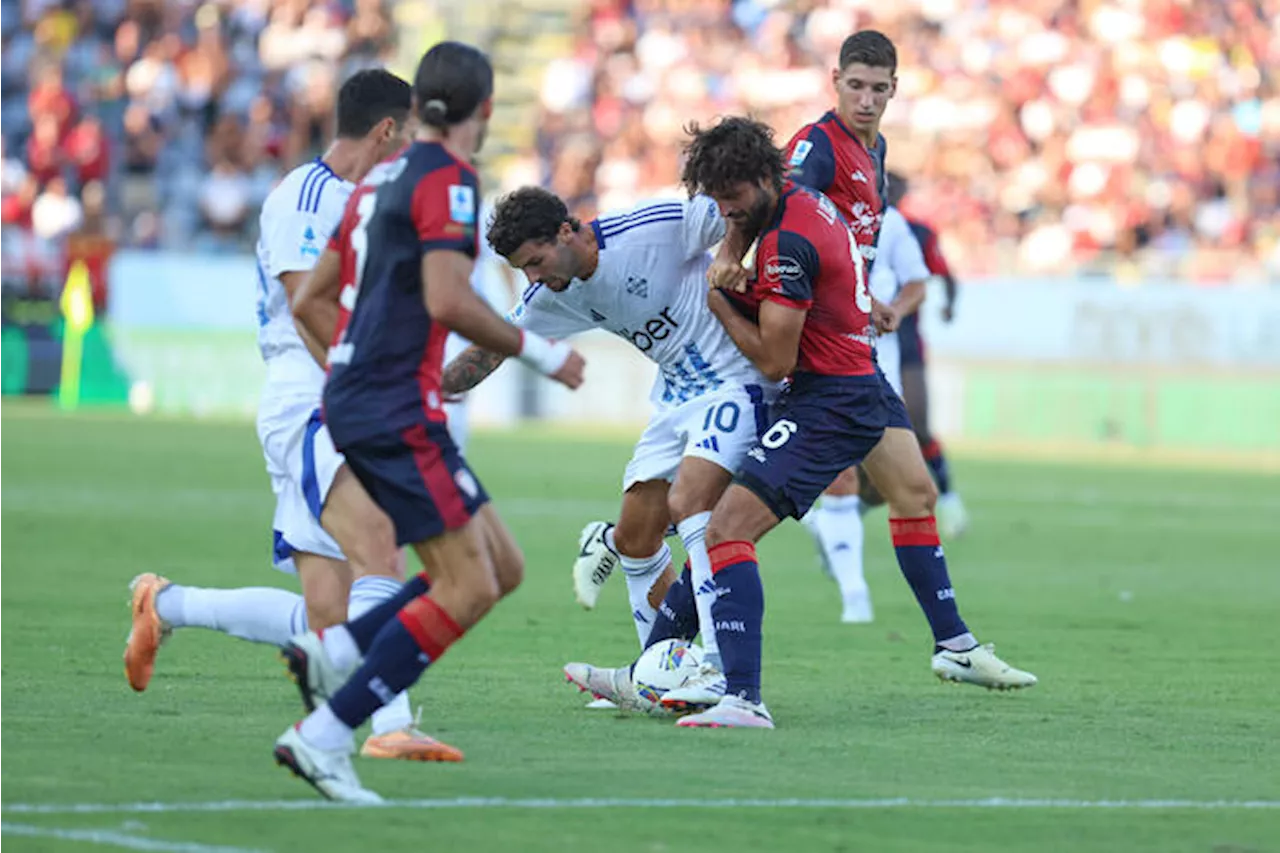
[443, 187, 777, 703]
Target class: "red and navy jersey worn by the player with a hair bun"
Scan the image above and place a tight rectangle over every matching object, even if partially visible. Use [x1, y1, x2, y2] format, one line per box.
[325, 142, 480, 447]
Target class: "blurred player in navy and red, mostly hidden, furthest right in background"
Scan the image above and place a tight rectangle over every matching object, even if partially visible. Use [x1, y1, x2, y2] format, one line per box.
[888, 172, 969, 538]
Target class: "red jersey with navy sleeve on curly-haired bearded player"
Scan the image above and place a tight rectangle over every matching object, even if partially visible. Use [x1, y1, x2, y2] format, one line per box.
[755, 181, 876, 377]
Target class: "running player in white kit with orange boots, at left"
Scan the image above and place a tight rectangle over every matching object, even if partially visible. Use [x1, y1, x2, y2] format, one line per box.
[124, 69, 460, 761]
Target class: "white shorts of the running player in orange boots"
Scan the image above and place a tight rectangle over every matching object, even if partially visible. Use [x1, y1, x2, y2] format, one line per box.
[257, 388, 346, 574]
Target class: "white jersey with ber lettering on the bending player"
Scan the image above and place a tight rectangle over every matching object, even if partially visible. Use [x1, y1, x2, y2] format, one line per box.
[508, 196, 776, 409]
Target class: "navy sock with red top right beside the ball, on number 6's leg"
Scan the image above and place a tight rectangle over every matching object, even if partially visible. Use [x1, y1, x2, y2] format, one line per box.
[707, 542, 764, 702]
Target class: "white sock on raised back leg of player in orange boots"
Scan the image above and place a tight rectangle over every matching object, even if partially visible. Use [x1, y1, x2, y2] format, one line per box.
[156, 584, 307, 646]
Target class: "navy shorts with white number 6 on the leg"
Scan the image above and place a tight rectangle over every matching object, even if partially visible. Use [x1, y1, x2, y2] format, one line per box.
[737, 368, 911, 519]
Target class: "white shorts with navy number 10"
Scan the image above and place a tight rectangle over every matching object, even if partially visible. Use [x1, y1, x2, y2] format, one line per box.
[622, 386, 777, 492]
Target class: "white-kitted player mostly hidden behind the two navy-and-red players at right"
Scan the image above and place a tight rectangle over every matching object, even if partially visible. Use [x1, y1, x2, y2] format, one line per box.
[804, 206, 929, 622]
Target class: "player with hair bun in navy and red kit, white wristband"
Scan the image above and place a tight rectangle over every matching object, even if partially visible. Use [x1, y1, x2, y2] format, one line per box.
[274, 41, 584, 802]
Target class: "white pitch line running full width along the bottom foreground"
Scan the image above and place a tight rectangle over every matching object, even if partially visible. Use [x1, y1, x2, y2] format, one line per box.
[0, 797, 1280, 815]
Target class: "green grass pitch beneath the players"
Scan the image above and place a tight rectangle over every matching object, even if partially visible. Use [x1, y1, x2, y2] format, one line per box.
[0, 402, 1280, 853]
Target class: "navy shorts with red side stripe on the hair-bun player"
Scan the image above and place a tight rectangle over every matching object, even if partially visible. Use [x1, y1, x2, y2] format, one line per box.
[340, 423, 489, 546]
